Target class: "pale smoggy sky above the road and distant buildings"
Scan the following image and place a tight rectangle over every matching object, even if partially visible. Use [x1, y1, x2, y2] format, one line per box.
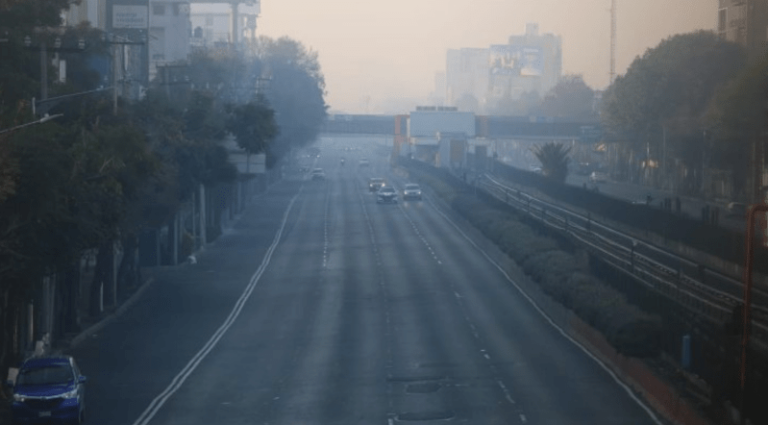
[257, 0, 717, 113]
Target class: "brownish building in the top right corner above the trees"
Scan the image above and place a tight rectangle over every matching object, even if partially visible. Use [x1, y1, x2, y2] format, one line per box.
[717, 0, 768, 60]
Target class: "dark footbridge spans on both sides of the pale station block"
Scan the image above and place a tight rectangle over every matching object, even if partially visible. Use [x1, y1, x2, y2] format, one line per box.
[321, 114, 602, 142]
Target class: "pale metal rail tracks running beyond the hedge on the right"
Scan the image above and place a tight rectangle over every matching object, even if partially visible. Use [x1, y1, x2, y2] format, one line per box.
[475, 175, 768, 351]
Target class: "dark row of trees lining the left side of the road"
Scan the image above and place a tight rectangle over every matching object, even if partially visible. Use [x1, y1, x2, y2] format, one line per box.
[0, 0, 326, 370]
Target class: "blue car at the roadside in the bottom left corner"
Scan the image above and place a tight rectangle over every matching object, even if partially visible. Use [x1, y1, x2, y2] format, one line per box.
[11, 356, 85, 424]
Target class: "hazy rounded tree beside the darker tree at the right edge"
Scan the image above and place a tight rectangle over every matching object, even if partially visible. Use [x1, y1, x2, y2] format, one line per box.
[600, 31, 746, 189]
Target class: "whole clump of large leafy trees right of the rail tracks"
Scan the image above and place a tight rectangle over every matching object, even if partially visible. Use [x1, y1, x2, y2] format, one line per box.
[601, 31, 766, 195]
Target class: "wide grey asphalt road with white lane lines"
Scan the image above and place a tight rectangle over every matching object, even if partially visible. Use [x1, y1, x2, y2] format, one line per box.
[72, 137, 658, 425]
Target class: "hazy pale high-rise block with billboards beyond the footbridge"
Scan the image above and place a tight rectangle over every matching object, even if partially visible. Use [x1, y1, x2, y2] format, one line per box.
[446, 24, 562, 112]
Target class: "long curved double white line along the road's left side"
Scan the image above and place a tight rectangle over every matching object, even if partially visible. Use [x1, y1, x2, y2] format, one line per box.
[133, 187, 303, 425]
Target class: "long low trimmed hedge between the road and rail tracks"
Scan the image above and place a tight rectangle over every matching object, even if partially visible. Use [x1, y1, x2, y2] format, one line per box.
[405, 163, 662, 357]
